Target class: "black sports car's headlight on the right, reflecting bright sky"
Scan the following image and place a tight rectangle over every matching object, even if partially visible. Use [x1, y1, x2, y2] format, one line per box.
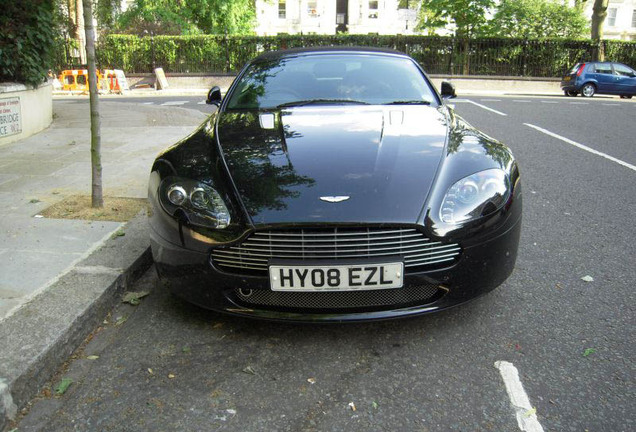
[439, 169, 510, 225]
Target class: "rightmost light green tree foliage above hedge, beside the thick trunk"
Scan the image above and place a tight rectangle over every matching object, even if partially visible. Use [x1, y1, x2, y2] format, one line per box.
[486, 0, 588, 39]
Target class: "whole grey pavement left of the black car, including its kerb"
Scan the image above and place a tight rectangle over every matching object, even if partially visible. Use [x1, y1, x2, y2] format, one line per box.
[0, 100, 206, 429]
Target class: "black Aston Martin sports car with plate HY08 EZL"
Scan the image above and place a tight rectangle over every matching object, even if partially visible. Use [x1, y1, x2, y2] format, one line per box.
[149, 48, 521, 321]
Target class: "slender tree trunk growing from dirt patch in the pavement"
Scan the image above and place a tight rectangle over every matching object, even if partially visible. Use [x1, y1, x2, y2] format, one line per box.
[84, 0, 104, 208]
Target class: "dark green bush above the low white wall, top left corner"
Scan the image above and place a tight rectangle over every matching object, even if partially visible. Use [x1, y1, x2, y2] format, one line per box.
[0, 0, 56, 86]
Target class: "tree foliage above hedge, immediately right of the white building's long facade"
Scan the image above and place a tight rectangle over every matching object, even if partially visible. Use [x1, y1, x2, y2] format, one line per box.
[417, 0, 495, 37]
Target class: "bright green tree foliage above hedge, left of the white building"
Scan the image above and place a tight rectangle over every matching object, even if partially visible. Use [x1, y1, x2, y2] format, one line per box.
[113, 0, 256, 35]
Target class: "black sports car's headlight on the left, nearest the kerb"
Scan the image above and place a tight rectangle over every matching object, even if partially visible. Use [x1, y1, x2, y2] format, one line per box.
[159, 177, 230, 229]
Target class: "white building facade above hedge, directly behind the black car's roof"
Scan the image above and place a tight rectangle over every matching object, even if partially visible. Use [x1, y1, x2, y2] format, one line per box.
[256, 0, 419, 36]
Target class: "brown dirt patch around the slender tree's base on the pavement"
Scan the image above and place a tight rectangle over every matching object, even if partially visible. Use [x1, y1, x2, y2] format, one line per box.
[40, 195, 148, 222]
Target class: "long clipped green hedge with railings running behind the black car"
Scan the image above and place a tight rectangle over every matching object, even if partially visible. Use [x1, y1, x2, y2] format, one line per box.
[80, 35, 636, 77]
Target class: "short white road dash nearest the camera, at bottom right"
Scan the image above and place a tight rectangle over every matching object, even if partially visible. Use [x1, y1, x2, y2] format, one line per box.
[495, 361, 543, 432]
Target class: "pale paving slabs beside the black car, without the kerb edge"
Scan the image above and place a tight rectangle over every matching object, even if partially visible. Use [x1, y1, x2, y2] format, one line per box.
[0, 101, 205, 319]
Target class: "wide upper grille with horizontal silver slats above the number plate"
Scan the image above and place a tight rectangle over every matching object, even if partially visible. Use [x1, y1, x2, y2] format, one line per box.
[211, 227, 460, 275]
